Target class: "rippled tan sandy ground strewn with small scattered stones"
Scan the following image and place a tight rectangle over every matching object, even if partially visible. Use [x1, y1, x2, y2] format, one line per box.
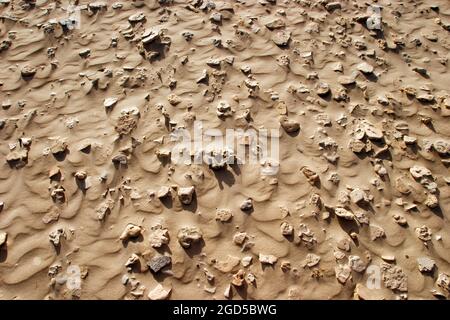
[0, 0, 450, 299]
